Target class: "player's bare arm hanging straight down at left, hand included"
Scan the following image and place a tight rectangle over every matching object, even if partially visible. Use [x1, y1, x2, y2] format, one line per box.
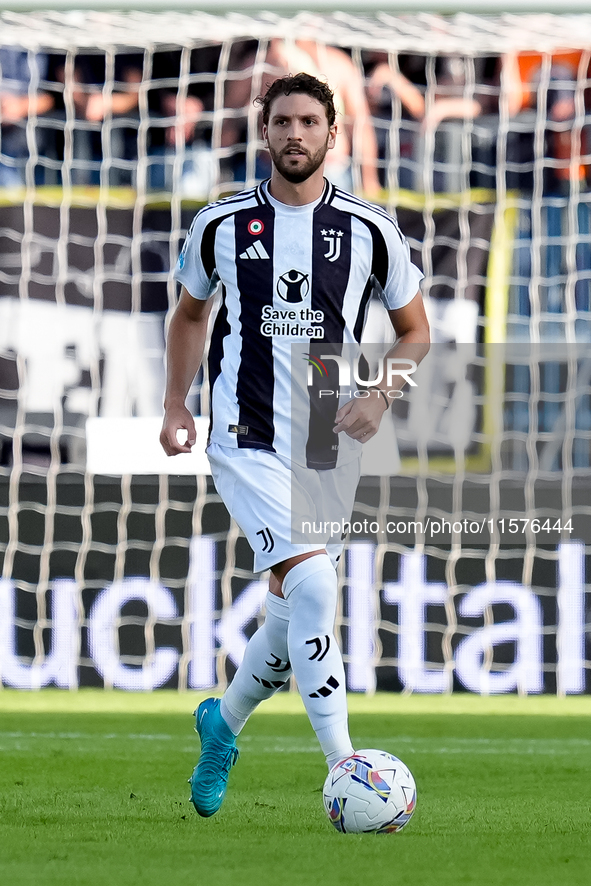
[160, 286, 213, 455]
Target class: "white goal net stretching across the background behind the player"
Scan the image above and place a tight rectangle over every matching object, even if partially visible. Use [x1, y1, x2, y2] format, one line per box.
[0, 12, 591, 694]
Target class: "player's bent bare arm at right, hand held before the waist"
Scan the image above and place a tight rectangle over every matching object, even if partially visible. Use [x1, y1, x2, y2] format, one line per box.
[334, 292, 430, 443]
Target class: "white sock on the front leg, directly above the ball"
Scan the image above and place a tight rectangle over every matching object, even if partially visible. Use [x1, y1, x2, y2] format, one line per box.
[283, 554, 353, 765]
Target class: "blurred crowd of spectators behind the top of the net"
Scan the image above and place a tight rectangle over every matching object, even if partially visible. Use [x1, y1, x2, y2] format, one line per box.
[0, 38, 591, 199]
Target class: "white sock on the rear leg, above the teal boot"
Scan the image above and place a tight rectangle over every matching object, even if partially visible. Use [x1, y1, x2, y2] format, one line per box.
[220, 593, 291, 735]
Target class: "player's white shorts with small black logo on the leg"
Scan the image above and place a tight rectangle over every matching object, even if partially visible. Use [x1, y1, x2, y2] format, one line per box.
[207, 443, 361, 572]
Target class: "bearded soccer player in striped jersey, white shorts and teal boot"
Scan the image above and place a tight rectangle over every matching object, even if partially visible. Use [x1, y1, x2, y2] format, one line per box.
[160, 74, 429, 816]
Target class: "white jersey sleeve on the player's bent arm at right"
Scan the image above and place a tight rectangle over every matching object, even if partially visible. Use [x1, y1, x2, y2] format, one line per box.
[375, 221, 424, 311]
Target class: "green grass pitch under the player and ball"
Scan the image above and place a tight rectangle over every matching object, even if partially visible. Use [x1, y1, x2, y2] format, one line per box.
[0, 690, 591, 886]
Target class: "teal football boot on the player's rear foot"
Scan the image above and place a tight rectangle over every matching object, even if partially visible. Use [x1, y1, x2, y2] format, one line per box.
[189, 698, 238, 818]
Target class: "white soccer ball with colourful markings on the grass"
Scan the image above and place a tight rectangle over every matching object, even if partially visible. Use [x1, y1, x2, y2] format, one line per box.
[322, 750, 417, 834]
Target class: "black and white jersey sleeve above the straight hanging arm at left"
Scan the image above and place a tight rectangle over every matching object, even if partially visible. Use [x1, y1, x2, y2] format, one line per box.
[173, 211, 219, 301]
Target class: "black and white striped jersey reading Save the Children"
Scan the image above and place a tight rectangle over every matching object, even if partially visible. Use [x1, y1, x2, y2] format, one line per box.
[174, 182, 422, 468]
